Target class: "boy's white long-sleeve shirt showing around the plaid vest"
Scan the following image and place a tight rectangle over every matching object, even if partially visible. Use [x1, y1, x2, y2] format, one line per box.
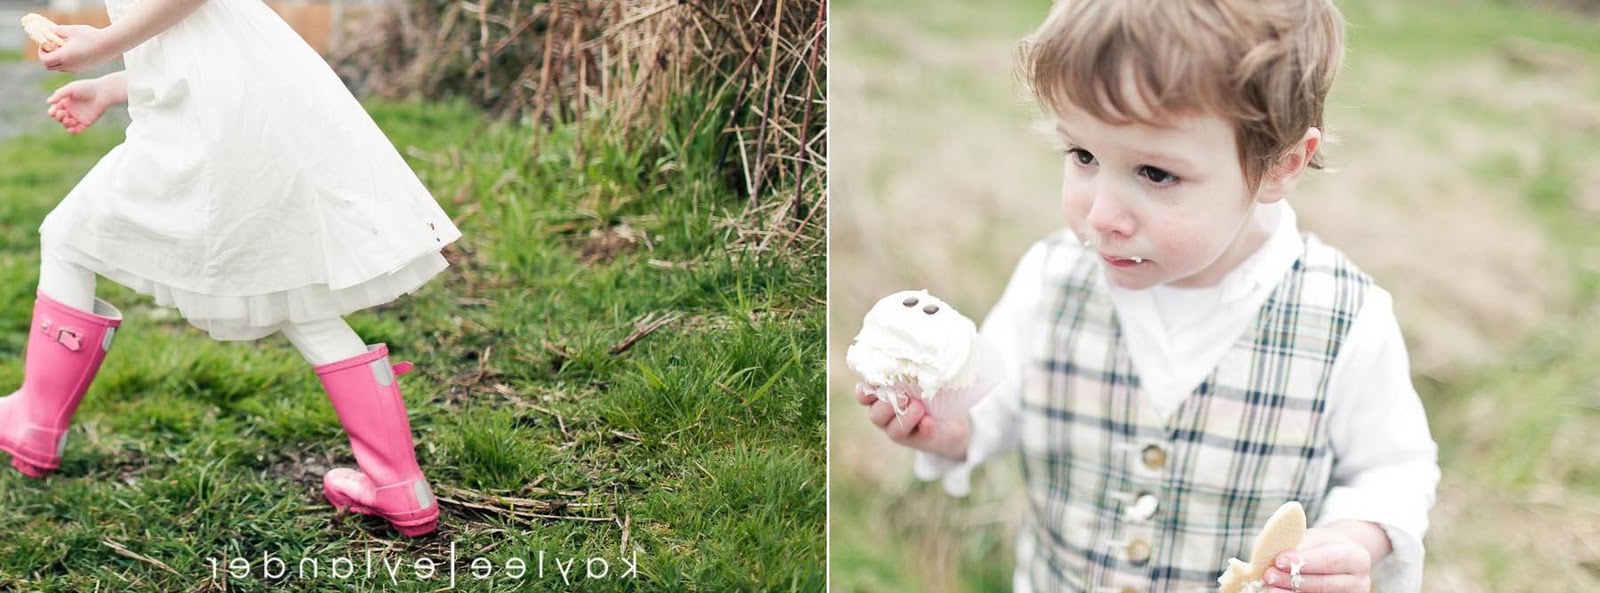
[917, 201, 1440, 593]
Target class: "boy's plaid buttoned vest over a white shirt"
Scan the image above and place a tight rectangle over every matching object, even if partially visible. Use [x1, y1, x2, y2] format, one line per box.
[1018, 233, 1371, 593]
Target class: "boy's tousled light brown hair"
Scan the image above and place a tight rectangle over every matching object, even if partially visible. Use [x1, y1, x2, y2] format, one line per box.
[1018, 0, 1344, 190]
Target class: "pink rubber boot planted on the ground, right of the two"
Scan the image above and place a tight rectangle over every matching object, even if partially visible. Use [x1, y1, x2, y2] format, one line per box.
[317, 344, 438, 537]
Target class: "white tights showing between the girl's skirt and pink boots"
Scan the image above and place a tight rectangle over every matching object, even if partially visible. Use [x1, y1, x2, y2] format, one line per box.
[38, 246, 366, 366]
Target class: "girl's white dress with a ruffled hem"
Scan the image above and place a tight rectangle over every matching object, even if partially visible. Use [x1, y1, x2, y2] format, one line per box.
[38, 0, 461, 340]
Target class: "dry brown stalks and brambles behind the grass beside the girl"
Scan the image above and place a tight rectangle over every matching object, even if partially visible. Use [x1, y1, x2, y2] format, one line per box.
[334, 0, 827, 242]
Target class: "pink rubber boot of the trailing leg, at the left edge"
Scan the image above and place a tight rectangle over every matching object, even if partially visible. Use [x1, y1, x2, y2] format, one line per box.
[0, 293, 122, 478]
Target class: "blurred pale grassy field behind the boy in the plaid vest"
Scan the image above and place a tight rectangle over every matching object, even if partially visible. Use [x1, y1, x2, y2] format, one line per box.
[829, 0, 1600, 593]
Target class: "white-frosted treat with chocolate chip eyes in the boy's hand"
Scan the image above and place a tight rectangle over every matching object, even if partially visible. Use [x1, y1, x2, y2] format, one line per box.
[845, 291, 978, 412]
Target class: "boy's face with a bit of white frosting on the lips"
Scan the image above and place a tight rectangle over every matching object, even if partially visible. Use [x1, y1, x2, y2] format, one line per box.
[1056, 105, 1254, 295]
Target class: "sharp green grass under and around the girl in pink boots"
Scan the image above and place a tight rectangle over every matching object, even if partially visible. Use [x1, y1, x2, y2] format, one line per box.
[0, 97, 826, 591]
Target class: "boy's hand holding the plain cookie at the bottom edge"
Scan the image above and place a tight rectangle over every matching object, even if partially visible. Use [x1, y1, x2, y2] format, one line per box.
[1264, 529, 1373, 593]
